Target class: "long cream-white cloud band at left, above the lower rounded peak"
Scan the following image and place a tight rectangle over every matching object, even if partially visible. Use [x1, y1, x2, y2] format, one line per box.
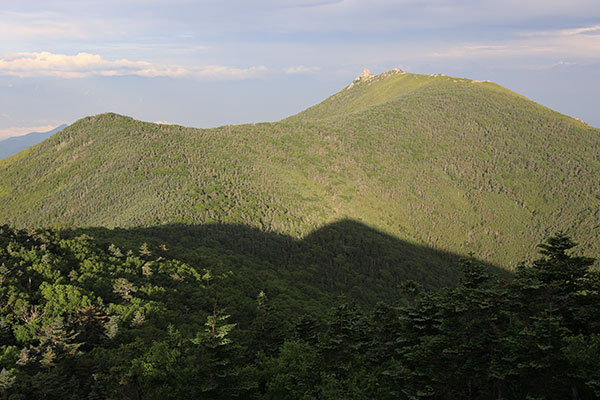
[0, 52, 267, 80]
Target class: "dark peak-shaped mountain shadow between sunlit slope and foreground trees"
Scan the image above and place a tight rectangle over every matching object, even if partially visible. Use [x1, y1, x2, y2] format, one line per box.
[69, 219, 508, 318]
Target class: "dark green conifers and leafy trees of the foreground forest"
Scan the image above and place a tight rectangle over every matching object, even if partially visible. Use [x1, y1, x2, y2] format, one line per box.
[0, 226, 600, 400]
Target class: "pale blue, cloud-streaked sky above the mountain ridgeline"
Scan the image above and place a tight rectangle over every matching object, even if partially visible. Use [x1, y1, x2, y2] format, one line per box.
[0, 0, 600, 140]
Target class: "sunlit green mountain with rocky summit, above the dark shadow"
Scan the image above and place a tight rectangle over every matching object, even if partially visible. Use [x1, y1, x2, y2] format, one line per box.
[0, 70, 600, 268]
